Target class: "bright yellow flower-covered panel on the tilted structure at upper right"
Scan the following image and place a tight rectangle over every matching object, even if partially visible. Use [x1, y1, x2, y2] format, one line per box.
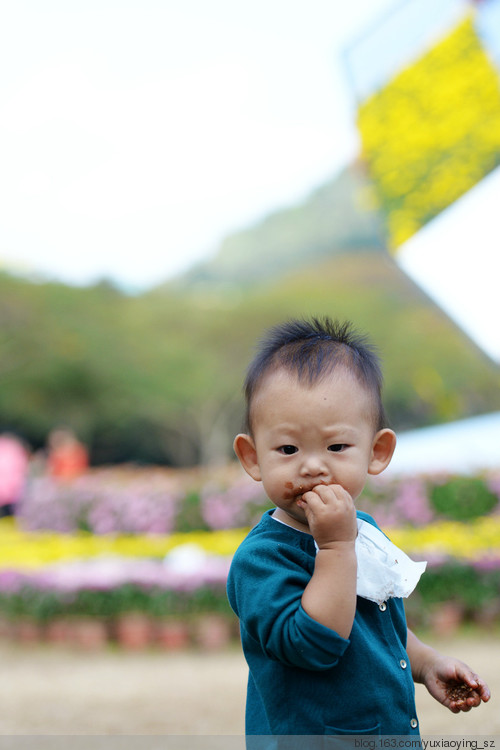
[358, 16, 500, 247]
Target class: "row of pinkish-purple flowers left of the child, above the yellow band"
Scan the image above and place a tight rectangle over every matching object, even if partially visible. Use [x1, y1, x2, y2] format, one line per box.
[18, 466, 269, 535]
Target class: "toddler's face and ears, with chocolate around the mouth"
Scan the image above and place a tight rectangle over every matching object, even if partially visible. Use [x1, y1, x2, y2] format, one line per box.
[235, 368, 395, 527]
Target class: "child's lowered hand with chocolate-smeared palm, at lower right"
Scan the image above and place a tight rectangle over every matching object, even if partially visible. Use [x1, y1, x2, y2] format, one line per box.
[423, 656, 491, 714]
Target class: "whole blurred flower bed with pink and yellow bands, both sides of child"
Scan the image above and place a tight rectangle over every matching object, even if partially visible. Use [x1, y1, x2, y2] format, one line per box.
[0, 467, 500, 644]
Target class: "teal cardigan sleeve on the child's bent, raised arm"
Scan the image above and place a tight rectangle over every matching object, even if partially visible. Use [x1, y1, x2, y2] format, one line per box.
[228, 543, 349, 670]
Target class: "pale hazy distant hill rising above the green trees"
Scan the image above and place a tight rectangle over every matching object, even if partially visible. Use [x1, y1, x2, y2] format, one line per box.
[179, 164, 385, 286]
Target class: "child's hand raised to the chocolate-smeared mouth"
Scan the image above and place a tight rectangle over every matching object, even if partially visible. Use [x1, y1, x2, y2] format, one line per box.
[298, 484, 358, 549]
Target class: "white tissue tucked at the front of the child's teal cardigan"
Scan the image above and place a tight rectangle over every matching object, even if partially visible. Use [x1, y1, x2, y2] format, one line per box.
[355, 518, 427, 604]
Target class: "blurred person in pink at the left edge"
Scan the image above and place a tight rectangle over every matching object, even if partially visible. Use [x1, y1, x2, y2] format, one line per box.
[0, 433, 29, 518]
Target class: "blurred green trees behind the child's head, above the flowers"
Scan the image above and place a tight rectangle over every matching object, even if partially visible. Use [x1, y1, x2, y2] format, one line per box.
[0, 241, 500, 466]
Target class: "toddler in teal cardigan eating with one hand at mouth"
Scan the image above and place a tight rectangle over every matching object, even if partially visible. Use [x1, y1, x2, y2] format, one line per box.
[227, 318, 490, 746]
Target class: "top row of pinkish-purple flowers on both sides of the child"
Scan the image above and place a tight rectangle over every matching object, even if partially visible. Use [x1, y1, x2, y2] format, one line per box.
[17, 465, 500, 538]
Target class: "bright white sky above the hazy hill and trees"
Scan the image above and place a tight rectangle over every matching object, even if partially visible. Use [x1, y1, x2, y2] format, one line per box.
[0, 0, 500, 360]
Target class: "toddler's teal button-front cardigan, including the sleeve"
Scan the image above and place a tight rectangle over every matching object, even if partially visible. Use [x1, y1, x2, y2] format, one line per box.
[227, 510, 419, 735]
